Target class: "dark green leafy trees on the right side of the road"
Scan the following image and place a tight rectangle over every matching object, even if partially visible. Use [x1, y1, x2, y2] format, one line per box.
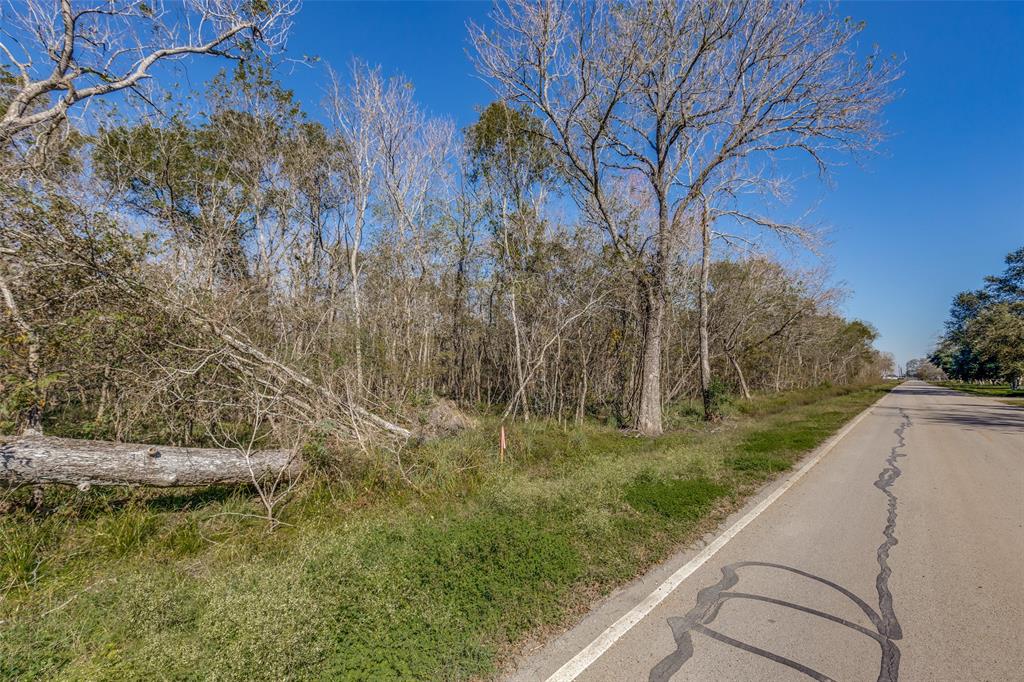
[929, 248, 1024, 388]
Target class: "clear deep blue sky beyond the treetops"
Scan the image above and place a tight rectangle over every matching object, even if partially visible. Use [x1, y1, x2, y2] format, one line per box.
[266, 0, 1024, 364]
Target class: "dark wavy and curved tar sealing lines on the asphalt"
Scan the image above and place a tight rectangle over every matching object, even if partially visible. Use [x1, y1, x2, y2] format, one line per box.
[648, 408, 911, 682]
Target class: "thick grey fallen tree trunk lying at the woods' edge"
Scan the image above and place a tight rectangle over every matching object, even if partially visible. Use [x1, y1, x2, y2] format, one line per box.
[0, 435, 301, 489]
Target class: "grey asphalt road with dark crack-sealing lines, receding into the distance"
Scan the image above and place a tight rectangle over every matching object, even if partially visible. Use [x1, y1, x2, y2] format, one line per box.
[512, 382, 1024, 682]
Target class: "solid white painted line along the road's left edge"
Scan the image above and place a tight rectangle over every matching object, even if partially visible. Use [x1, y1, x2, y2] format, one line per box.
[548, 393, 888, 682]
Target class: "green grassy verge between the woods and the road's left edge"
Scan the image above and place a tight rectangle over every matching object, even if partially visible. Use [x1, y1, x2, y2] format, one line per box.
[0, 378, 891, 680]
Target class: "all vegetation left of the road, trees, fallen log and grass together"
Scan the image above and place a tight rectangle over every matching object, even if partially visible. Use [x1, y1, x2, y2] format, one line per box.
[0, 0, 900, 680]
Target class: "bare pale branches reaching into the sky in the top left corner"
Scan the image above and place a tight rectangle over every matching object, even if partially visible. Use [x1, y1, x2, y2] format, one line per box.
[0, 0, 298, 154]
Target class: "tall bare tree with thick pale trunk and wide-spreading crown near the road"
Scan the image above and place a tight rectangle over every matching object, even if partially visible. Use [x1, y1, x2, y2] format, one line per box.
[471, 0, 895, 434]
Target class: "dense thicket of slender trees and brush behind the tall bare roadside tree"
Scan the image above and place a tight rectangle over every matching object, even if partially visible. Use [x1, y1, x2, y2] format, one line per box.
[0, 4, 891, 456]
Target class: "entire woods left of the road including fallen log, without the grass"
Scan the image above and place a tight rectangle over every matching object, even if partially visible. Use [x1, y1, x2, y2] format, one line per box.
[0, 0, 898, 484]
